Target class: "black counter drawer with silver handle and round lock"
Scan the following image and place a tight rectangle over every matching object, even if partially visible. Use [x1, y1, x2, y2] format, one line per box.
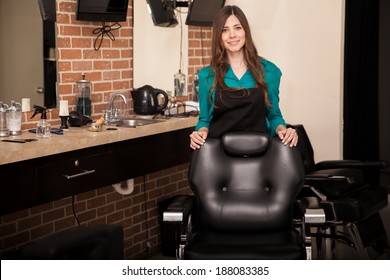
[36, 151, 116, 203]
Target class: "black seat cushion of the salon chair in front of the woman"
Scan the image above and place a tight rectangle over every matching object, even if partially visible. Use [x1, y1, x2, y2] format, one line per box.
[184, 230, 306, 260]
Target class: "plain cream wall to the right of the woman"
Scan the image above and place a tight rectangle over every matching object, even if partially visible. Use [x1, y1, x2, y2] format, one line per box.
[227, 0, 345, 161]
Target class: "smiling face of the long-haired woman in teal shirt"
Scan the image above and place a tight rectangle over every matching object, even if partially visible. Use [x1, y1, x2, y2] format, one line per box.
[221, 15, 245, 54]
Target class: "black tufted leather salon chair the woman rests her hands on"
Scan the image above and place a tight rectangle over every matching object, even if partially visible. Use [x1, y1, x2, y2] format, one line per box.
[163, 132, 316, 260]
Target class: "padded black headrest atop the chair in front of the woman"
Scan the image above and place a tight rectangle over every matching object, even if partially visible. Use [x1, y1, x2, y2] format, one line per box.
[222, 132, 270, 157]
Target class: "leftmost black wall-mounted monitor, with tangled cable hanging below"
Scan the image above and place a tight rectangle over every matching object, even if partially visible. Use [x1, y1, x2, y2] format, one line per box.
[76, 0, 129, 22]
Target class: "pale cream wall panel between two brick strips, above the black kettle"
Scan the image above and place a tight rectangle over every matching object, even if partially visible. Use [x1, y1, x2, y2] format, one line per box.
[133, 0, 188, 92]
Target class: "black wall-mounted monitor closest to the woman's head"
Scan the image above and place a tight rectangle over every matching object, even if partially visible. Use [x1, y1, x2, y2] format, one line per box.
[186, 0, 225, 26]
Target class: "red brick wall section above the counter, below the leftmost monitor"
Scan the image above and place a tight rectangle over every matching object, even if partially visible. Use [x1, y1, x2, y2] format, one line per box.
[22, 0, 133, 129]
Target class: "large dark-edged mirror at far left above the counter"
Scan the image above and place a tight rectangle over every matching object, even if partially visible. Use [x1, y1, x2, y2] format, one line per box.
[0, 0, 57, 108]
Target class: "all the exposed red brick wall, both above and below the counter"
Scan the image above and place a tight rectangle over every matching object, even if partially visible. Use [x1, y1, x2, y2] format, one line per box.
[0, 0, 211, 259]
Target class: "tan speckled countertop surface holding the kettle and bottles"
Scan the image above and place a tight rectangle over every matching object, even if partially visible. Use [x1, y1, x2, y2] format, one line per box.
[0, 117, 198, 165]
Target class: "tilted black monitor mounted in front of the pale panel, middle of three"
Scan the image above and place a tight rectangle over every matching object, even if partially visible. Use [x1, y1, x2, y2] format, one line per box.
[146, 0, 177, 27]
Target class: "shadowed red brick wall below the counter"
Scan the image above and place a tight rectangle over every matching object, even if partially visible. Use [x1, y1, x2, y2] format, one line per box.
[0, 164, 191, 259]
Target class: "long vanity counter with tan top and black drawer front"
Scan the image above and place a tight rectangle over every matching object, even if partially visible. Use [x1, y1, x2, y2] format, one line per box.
[0, 117, 197, 215]
